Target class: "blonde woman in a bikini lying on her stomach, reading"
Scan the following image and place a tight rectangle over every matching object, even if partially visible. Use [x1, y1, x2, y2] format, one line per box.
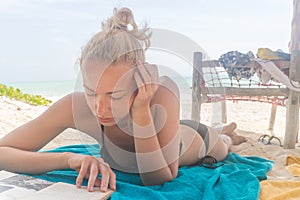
[0, 8, 245, 191]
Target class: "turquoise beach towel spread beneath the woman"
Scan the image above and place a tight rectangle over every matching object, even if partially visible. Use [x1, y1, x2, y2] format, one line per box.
[34, 145, 273, 200]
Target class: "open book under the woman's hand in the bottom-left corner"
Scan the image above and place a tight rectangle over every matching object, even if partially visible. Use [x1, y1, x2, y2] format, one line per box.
[0, 171, 113, 200]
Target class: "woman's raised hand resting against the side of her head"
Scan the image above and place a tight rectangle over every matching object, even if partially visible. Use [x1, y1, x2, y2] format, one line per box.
[131, 61, 159, 110]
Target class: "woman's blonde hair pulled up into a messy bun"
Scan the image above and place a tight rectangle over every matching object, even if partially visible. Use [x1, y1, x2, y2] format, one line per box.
[80, 7, 151, 67]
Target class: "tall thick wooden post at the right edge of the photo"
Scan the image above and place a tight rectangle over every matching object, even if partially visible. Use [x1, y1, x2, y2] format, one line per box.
[283, 0, 300, 149]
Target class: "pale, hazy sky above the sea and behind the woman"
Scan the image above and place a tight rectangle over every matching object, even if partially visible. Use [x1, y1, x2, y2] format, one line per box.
[0, 0, 293, 83]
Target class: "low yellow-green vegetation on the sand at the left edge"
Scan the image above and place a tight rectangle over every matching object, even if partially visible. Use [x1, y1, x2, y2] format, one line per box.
[0, 84, 52, 106]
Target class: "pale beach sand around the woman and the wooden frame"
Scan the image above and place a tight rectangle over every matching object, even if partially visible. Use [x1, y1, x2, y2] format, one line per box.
[0, 97, 300, 179]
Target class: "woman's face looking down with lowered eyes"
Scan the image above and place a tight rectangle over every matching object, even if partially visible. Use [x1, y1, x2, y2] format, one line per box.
[84, 63, 136, 126]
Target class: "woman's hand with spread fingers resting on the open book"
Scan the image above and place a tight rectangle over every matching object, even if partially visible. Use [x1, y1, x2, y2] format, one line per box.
[68, 153, 116, 192]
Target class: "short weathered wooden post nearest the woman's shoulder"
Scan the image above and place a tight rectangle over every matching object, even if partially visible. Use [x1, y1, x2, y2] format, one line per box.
[191, 52, 203, 122]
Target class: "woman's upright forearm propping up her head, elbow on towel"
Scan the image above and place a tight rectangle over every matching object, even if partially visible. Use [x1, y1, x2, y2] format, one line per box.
[131, 108, 174, 185]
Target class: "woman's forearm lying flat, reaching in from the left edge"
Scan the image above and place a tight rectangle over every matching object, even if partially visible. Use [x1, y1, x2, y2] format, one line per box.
[0, 147, 70, 174]
